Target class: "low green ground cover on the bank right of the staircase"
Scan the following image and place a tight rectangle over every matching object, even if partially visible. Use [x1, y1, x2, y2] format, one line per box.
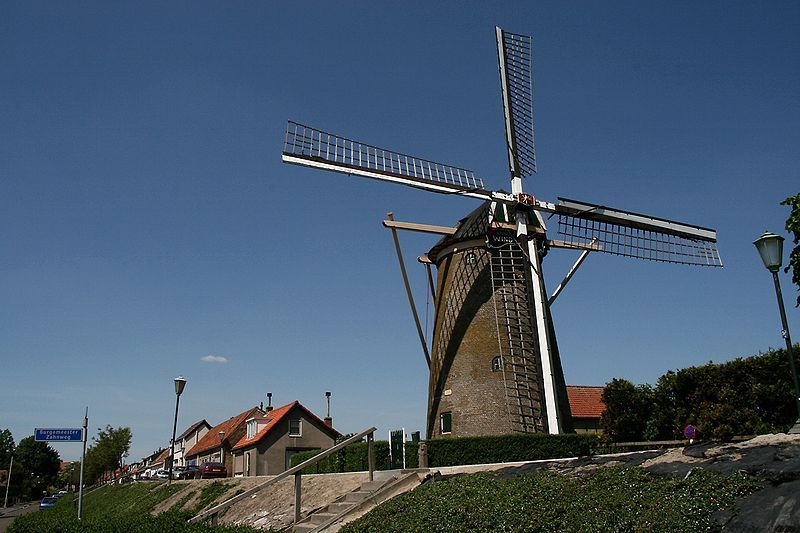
[341, 468, 760, 533]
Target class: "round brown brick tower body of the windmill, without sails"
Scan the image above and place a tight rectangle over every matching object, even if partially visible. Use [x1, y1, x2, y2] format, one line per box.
[427, 202, 572, 438]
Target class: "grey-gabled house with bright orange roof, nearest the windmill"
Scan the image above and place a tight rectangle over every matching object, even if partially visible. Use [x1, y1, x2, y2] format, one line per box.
[232, 400, 341, 476]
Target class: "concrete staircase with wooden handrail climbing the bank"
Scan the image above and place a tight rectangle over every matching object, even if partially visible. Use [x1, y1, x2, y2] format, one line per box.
[292, 469, 428, 533]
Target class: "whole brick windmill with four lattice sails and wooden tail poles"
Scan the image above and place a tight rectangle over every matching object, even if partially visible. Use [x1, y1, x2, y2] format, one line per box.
[282, 27, 722, 438]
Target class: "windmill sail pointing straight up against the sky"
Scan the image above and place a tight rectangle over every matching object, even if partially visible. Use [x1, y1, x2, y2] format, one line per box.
[495, 26, 536, 177]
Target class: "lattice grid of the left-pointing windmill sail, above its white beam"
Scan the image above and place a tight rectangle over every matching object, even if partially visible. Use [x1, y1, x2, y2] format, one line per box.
[283, 121, 483, 190]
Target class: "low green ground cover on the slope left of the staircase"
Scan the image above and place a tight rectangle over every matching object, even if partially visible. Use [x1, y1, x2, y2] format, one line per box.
[7, 483, 262, 533]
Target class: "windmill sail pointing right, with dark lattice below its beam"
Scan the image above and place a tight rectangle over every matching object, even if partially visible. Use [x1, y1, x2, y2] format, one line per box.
[555, 198, 722, 267]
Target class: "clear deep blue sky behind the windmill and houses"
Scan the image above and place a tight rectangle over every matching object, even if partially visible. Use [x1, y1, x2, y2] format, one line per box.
[0, 2, 800, 459]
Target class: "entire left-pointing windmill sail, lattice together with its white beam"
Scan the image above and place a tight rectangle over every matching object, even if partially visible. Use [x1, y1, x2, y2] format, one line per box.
[282, 121, 491, 199]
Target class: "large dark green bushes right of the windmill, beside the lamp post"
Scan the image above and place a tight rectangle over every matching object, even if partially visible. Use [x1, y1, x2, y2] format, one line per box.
[600, 346, 798, 442]
